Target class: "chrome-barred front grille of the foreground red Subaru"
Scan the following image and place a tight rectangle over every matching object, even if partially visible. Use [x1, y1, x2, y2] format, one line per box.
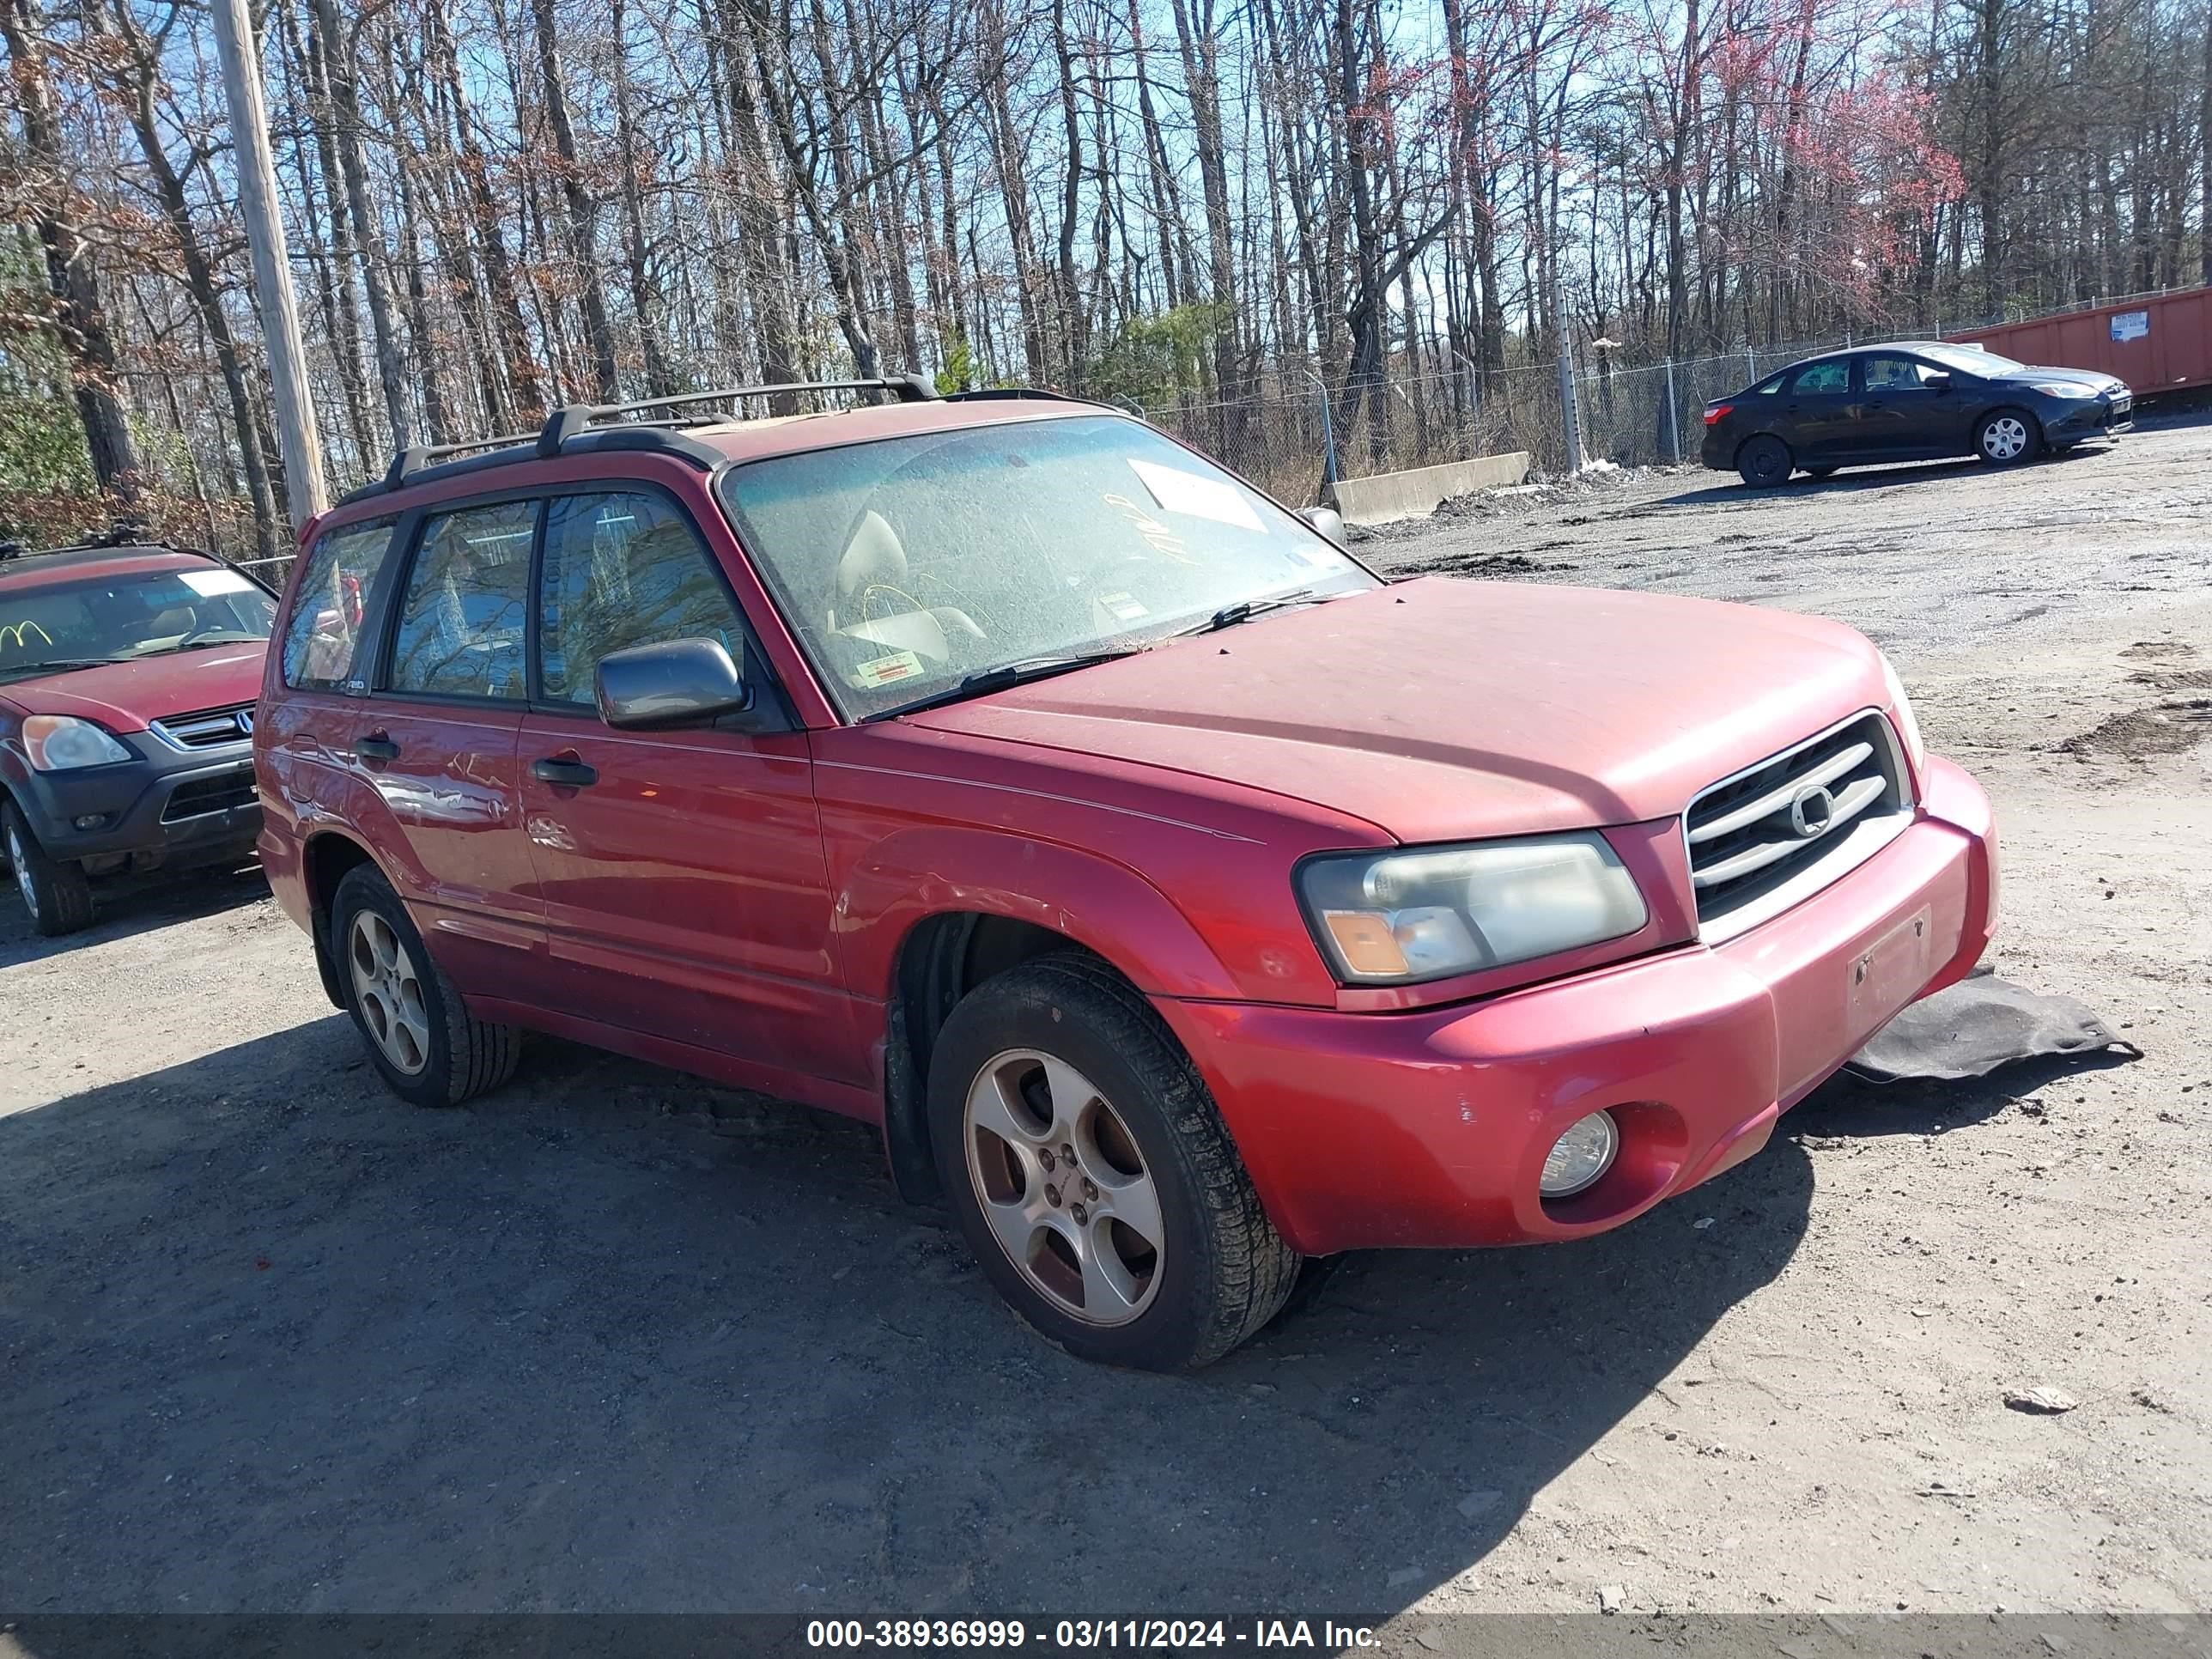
[1683, 714, 1911, 922]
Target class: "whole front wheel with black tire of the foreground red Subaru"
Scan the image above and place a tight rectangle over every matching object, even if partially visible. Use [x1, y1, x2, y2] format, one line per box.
[929, 951, 1298, 1371]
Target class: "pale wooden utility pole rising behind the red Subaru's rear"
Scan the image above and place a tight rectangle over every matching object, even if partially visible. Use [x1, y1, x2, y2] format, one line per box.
[210, 0, 330, 533]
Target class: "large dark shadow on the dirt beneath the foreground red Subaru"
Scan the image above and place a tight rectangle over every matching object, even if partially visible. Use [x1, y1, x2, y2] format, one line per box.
[0, 1018, 1812, 1617]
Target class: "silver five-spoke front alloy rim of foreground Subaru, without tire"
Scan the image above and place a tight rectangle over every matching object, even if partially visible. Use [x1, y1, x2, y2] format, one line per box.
[963, 1048, 1166, 1325]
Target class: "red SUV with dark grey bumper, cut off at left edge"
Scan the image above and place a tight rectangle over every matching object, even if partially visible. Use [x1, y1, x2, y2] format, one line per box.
[0, 540, 276, 936]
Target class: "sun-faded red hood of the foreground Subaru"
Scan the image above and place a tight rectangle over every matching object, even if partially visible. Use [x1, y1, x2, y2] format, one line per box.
[909, 577, 1887, 841]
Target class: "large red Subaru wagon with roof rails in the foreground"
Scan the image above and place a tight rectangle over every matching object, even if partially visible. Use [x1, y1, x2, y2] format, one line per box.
[254, 383, 1996, 1370]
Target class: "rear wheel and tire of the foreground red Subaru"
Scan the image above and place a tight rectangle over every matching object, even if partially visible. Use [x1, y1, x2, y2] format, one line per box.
[330, 865, 522, 1106]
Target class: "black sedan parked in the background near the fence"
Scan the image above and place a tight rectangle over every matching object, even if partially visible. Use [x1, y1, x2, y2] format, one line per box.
[1698, 341, 2135, 489]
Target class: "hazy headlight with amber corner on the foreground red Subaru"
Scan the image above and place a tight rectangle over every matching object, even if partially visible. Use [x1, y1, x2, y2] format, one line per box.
[1298, 830, 1648, 984]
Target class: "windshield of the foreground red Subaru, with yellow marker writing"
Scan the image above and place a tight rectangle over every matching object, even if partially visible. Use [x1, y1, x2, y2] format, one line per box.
[721, 416, 1376, 719]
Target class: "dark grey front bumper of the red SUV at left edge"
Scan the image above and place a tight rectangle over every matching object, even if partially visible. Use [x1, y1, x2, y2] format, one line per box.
[9, 732, 261, 869]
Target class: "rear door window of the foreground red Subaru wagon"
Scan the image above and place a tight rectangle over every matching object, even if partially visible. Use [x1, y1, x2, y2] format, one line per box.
[385, 500, 540, 702]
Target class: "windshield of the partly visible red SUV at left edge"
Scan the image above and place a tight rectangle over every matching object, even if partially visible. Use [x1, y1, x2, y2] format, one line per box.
[0, 564, 276, 681]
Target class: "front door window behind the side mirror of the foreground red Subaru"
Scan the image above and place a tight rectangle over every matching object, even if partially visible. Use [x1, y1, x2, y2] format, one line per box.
[538, 493, 745, 703]
